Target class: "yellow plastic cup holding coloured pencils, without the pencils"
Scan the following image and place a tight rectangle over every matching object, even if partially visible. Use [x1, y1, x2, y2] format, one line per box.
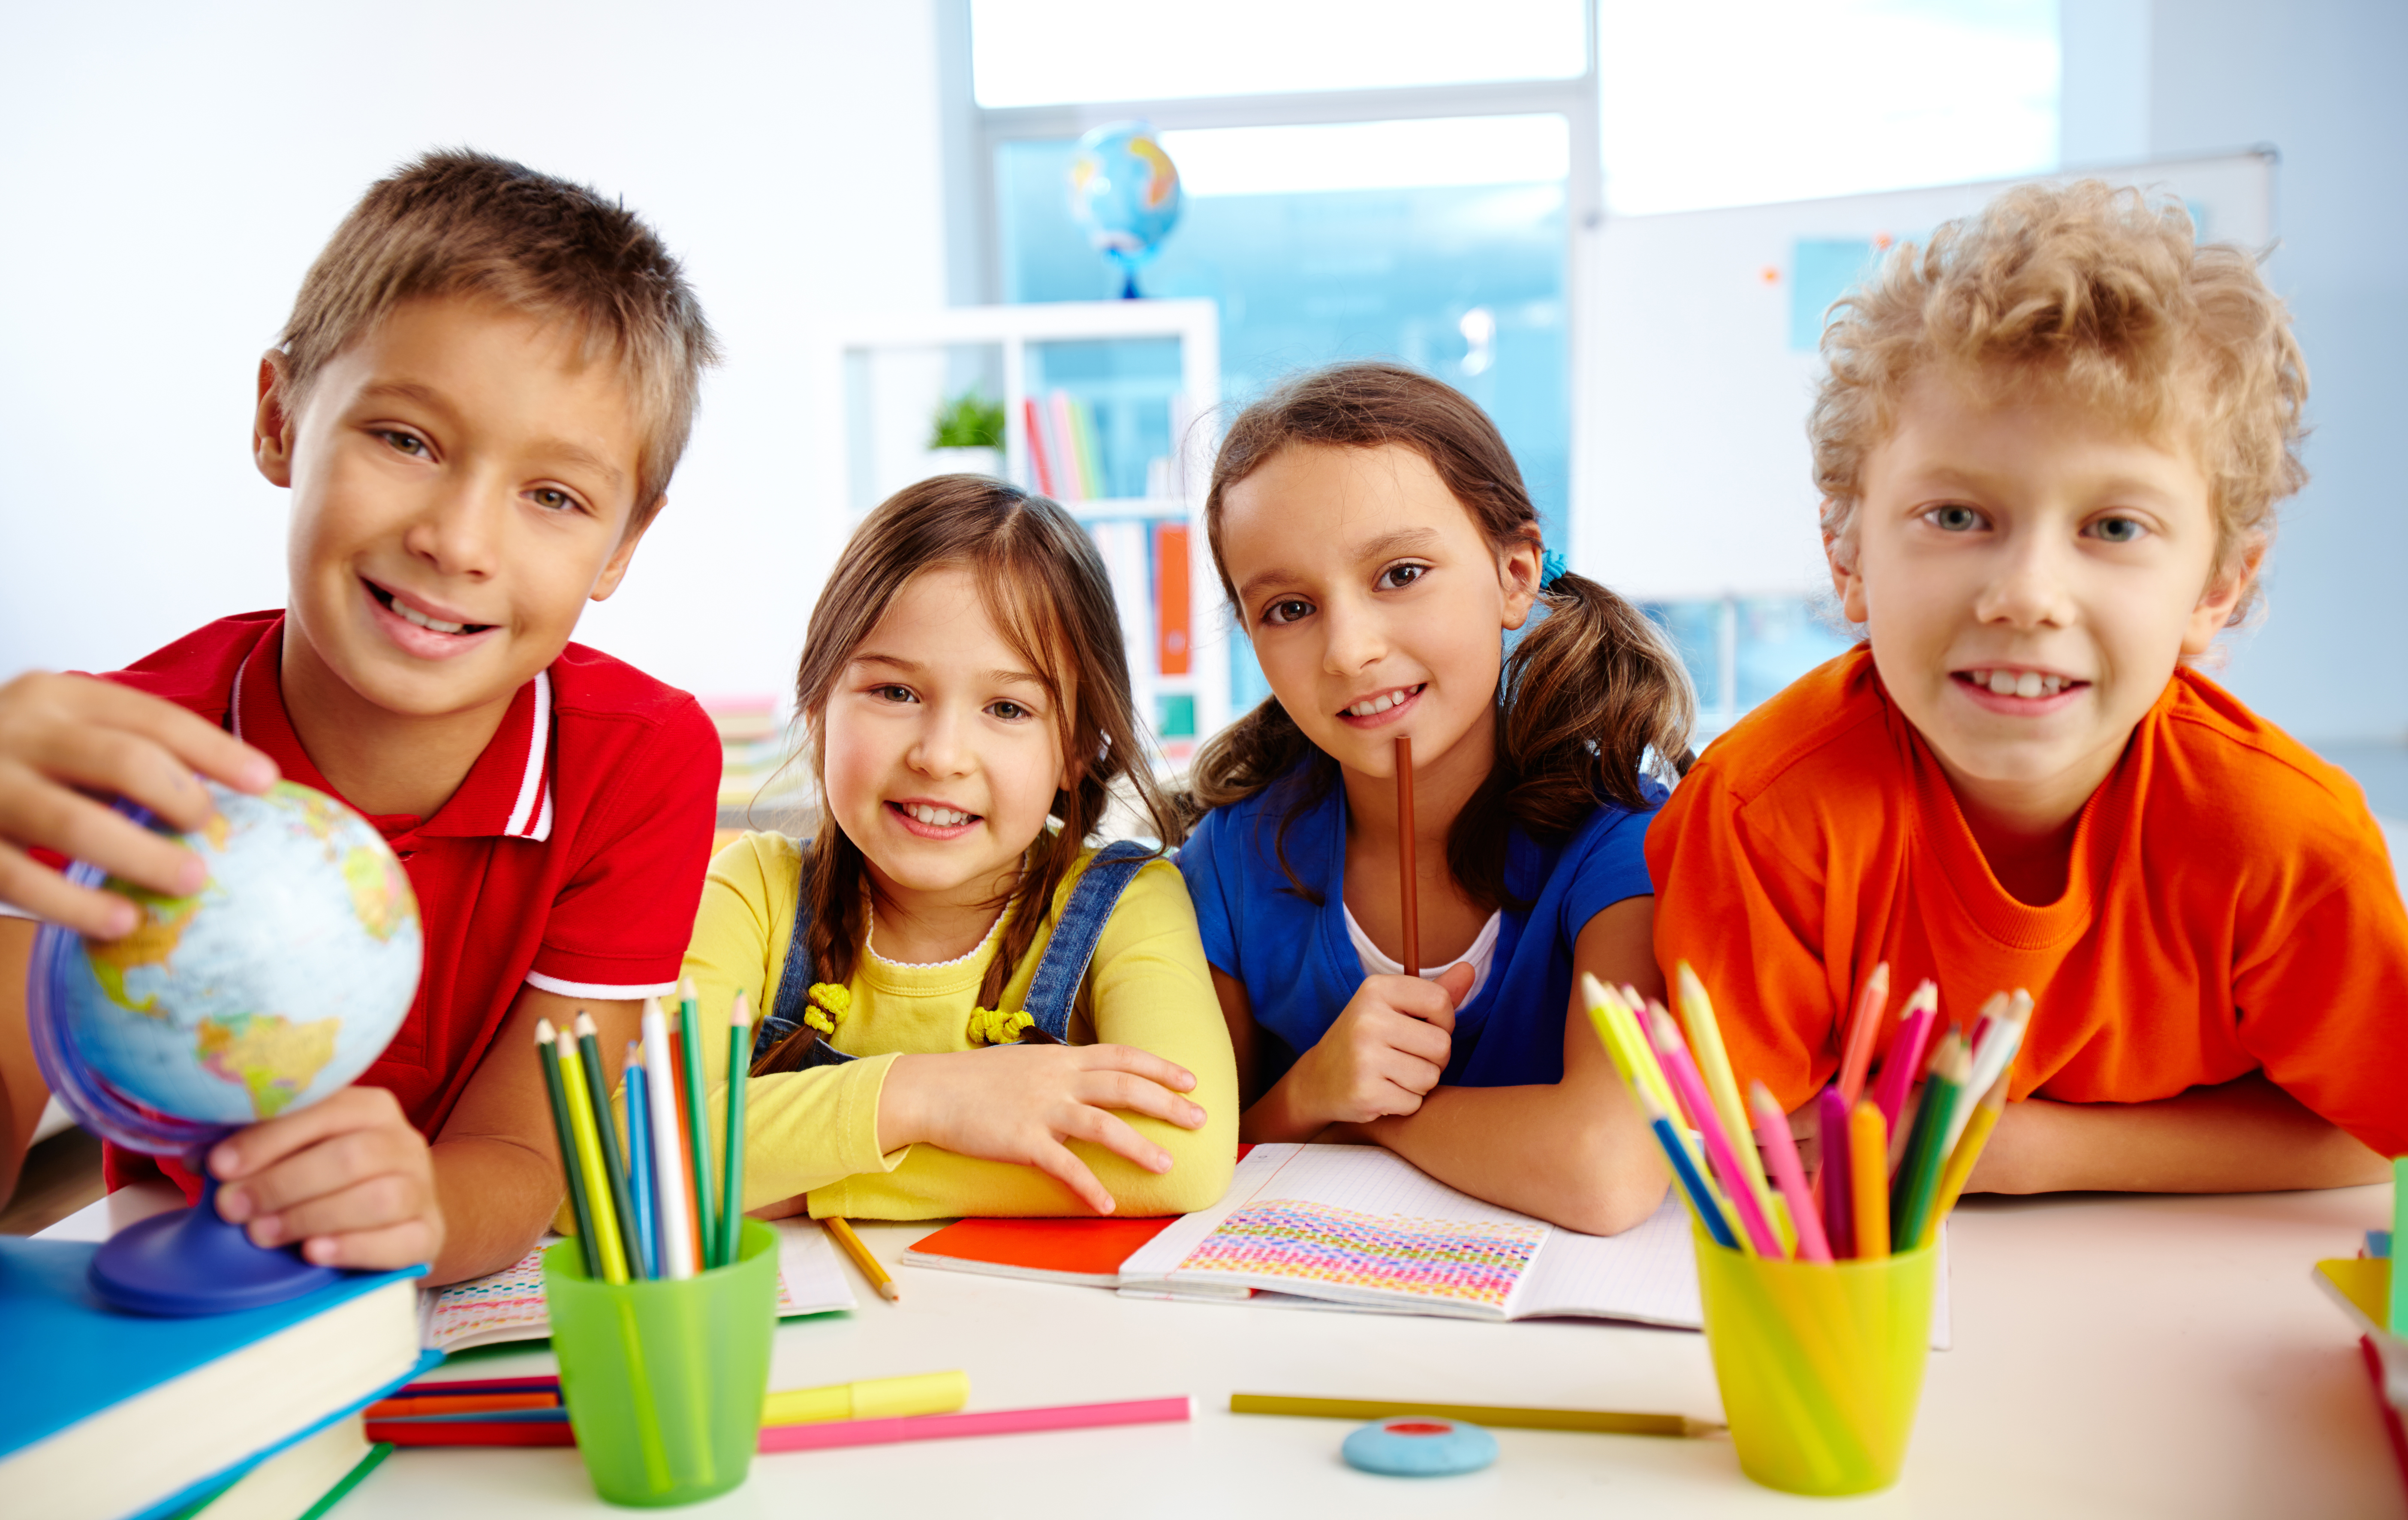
[1695, 1228, 1938, 1493]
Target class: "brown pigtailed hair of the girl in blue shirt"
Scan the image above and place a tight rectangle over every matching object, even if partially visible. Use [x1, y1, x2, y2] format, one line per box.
[1187, 364, 1695, 908]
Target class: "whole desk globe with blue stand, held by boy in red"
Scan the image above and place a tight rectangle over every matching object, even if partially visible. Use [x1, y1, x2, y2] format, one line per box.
[27, 781, 424, 1313]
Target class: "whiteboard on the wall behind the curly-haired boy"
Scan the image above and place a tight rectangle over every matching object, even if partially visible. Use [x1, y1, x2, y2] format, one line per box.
[1572, 149, 2276, 602]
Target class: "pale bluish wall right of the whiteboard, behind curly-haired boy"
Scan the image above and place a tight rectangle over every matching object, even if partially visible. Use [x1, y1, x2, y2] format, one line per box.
[2128, 0, 2408, 742]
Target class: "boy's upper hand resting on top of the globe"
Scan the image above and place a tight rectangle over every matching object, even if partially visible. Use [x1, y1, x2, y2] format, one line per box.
[0, 670, 277, 939]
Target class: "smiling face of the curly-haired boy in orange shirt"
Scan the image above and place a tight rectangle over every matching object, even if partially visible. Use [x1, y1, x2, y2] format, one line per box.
[1833, 374, 2256, 826]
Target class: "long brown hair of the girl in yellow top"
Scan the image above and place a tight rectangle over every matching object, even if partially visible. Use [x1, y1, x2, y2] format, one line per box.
[754, 474, 1180, 1072]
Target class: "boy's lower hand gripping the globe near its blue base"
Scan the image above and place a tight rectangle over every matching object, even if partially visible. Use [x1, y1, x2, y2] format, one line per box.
[210, 1086, 443, 1272]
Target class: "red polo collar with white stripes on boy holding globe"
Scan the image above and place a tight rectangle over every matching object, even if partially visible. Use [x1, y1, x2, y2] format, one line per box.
[226, 617, 551, 848]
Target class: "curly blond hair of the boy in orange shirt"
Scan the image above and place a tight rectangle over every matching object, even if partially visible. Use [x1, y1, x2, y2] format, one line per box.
[1806, 181, 2307, 624]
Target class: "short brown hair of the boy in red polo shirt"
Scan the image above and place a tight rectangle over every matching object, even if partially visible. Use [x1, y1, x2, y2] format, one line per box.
[277, 147, 720, 532]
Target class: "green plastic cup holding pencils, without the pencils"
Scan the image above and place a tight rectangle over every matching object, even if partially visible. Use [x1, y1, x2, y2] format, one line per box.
[544, 1219, 778, 1508]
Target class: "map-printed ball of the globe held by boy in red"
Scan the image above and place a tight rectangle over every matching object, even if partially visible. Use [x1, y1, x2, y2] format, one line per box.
[53, 781, 421, 1125]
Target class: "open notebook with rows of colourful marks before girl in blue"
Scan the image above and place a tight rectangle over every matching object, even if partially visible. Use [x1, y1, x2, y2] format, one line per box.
[1120, 1144, 1948, 1347]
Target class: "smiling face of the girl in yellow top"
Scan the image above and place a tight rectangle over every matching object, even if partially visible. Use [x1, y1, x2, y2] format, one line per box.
[821, 566, 1064, 908]
